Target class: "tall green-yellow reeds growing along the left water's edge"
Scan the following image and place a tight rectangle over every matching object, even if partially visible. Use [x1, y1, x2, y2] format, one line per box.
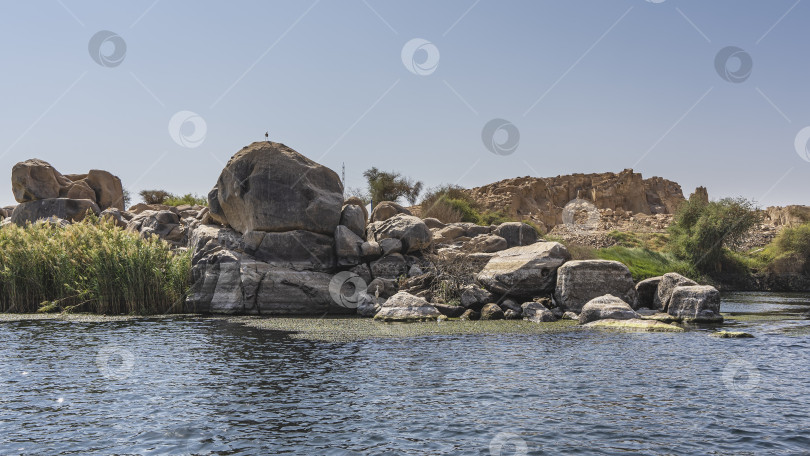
[0, 217, 191, 314]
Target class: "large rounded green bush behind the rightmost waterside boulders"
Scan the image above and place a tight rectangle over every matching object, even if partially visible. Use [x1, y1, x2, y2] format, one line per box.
[669, 198, 762, 273]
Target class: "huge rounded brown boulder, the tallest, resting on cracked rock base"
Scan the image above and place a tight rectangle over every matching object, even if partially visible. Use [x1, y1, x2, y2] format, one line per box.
[208, 141, 343, 236]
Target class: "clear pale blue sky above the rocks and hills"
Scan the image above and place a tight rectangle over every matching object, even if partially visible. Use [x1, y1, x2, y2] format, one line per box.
[0, 0, 810, 205]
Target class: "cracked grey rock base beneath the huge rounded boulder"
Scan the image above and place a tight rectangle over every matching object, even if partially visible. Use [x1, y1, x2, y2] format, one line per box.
[186, 225, 346, 315]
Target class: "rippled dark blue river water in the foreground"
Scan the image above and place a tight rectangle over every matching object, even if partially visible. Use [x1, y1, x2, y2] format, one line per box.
[0, 294, 810, 456]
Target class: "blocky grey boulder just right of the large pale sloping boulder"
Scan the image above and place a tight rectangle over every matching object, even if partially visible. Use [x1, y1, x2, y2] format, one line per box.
[554, 260, 636, 313]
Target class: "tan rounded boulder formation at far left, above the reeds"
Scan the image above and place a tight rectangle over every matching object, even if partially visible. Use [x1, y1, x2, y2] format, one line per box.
[11, 158, 124, 210]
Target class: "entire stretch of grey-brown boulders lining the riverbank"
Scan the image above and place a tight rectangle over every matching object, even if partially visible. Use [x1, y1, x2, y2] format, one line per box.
[4, 142, 722, 328]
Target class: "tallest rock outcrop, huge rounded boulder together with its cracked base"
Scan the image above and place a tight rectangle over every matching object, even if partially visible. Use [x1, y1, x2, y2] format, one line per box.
[189, 142, 354, 315]
